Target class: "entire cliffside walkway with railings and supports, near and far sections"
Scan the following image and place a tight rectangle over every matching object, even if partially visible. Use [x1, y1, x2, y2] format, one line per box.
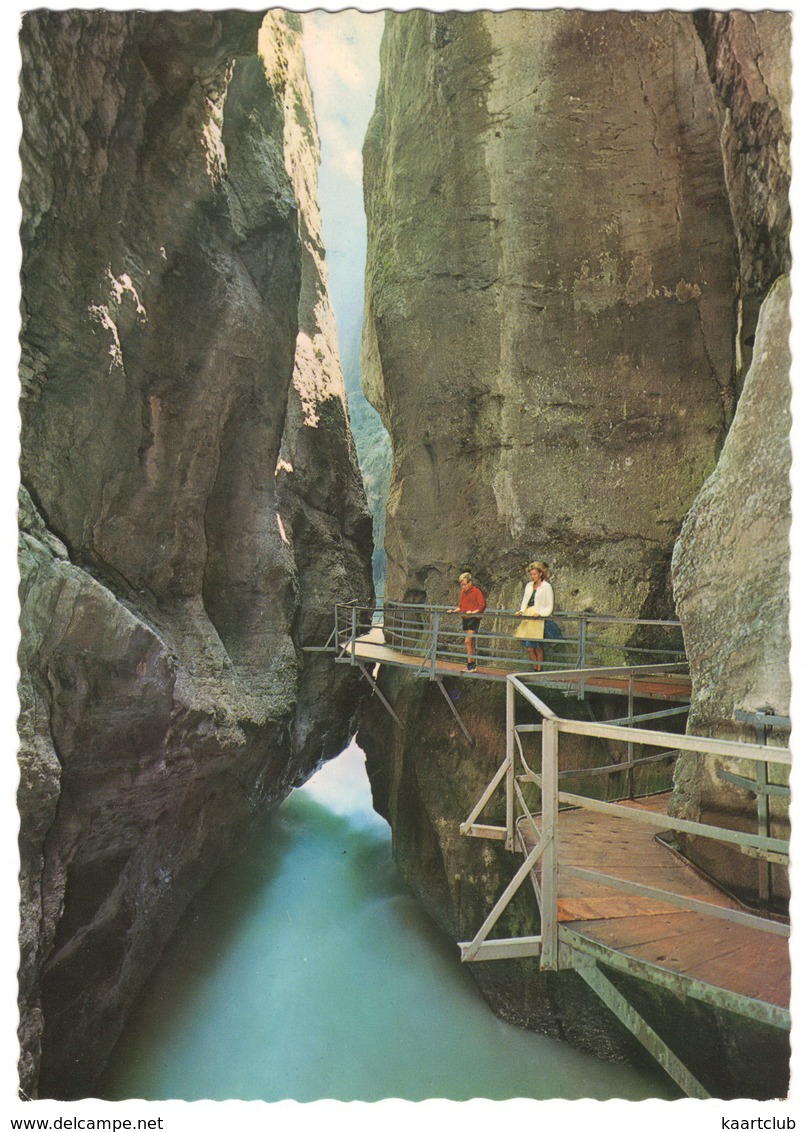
[326, 604, 792, 1097]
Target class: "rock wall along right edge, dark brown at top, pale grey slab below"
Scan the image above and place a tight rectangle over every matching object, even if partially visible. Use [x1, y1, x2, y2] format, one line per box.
[672, 12, 791, 910]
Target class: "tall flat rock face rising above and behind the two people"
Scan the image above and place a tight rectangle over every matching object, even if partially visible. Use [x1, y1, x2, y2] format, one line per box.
[364, 10, 738, 615]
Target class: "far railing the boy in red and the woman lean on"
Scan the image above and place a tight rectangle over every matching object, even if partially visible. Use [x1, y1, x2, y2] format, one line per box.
[332, 601, 686, 679]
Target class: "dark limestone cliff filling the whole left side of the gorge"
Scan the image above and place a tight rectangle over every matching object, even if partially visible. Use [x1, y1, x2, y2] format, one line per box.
[19, 11, 371, 1097]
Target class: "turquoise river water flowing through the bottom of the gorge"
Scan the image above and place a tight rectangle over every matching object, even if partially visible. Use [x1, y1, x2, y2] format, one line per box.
[100, 745, 676, 1101]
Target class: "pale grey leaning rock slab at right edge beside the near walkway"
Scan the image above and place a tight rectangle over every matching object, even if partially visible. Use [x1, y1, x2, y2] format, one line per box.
[672, 276, 791, 906]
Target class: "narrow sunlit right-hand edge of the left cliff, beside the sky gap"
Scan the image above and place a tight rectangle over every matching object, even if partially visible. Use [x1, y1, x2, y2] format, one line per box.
[267, 12, 372, 772]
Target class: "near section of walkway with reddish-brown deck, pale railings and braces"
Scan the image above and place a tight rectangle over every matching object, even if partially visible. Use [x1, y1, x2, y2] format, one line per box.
[460, 675, 792, 1097]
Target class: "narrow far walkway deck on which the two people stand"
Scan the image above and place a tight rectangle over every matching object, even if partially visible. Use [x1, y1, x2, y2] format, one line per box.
[337, 628, 692, 703]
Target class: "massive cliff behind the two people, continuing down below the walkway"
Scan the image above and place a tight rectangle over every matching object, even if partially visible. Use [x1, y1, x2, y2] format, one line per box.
[359, 11, 789, 1096]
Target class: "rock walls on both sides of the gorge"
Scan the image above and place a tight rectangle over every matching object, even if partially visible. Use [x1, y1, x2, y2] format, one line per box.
[18, 10, 790, 1099]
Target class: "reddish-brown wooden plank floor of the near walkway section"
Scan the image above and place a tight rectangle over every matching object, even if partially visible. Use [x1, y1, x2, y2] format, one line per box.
[518, 795, 790, 1014]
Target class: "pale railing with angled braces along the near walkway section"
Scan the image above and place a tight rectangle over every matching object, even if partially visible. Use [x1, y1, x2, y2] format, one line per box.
[460, 676, 791, 970]
